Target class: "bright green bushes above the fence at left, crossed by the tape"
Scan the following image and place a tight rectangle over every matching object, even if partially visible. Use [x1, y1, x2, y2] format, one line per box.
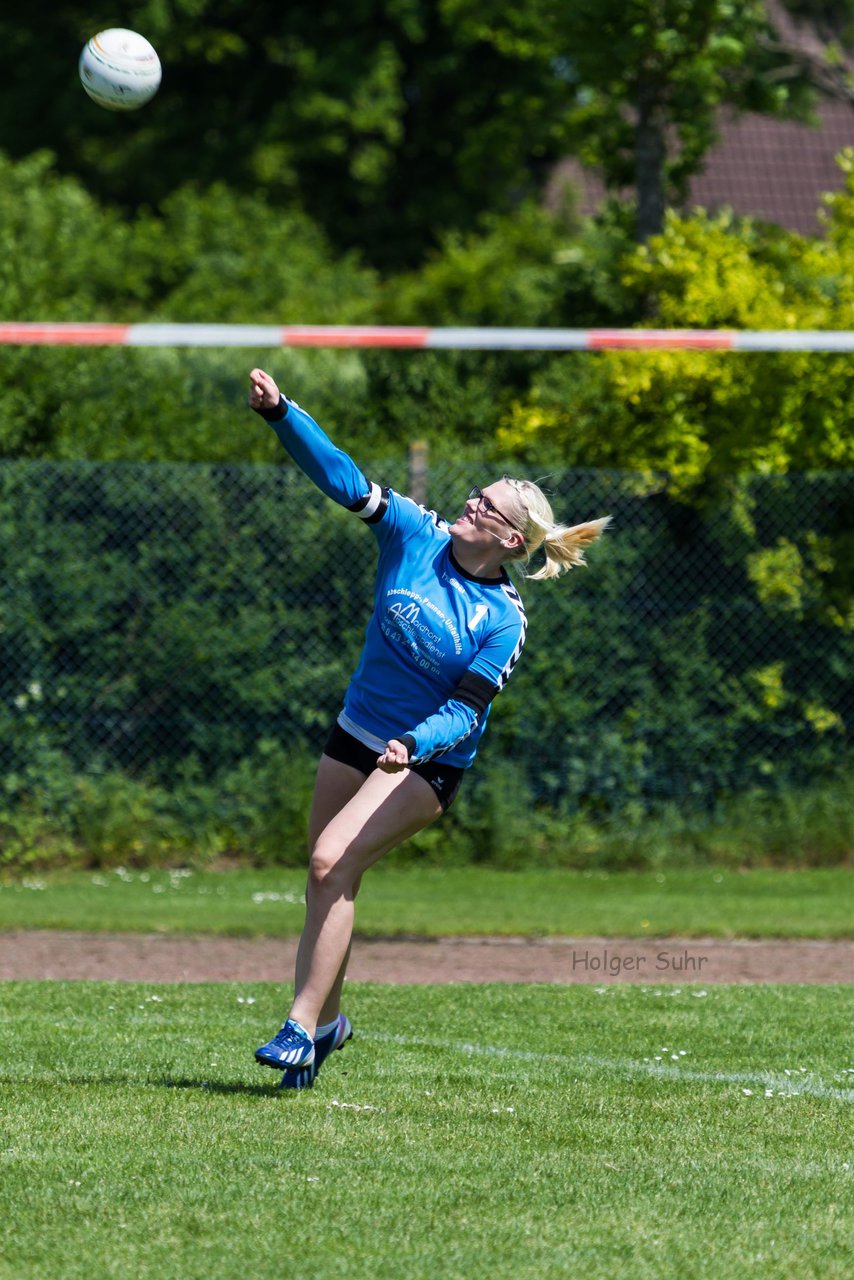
[0, 154, 376, 460]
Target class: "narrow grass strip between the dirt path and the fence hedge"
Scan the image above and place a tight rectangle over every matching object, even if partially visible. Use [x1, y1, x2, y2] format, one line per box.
[0, 867, 854, 938]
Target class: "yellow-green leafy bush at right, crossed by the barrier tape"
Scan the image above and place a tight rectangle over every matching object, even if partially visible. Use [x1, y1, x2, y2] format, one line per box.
[499, 152, 854, 481]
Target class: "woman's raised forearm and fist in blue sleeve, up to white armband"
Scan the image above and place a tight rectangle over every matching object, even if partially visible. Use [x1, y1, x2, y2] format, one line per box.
[248, 369, 388, 522]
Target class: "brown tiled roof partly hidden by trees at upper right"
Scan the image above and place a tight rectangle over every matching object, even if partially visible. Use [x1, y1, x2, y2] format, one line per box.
[549, 100, 854, 236]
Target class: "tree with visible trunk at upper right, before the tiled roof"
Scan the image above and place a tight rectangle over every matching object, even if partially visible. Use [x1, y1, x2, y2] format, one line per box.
[444, 0, 808, 241]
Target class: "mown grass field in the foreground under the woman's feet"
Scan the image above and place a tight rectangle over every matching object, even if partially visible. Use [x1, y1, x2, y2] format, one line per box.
[0, 983, 854, 1280]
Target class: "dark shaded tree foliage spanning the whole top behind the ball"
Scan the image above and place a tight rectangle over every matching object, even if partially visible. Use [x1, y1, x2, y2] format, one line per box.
[0, 0, 829, 259]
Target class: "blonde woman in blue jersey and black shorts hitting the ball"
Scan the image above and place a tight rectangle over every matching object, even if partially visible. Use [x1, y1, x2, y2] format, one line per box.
[248, 369, 609, 1089]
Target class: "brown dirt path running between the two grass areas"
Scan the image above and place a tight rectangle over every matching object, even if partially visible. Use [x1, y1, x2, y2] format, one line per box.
[0, 931, 854, 986]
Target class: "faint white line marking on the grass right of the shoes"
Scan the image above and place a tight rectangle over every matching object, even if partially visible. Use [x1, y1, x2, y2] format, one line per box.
[360, 1032, 854, 1102]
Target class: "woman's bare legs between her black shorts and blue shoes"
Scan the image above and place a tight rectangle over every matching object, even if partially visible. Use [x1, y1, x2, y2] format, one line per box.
[289, 762, 442, 1036]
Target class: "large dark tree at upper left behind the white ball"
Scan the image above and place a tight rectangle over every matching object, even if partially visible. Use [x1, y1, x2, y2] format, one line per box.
[0, 0, 563, 266]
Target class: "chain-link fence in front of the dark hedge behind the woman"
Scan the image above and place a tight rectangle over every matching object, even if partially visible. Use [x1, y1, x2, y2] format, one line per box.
[0, 458, 854, 813]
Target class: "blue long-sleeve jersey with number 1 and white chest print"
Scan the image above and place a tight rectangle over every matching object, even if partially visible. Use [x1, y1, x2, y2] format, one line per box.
[262, 397, 526, 768]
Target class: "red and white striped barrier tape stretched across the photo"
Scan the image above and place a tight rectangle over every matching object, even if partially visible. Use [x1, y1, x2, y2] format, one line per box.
[0, 321, 854, 352]
